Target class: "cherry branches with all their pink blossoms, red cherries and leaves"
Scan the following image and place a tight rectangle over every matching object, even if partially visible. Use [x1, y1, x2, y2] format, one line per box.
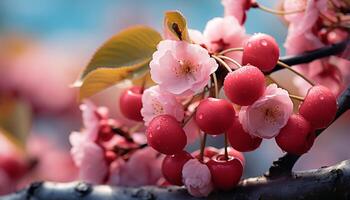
[3, 0, 350, 200]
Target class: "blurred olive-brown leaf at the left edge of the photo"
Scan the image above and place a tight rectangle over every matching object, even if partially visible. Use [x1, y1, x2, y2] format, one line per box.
[0, 97, 32, 151]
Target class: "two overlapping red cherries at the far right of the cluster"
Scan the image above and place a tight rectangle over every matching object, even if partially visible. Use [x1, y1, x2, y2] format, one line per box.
[276, 86, 337, 155]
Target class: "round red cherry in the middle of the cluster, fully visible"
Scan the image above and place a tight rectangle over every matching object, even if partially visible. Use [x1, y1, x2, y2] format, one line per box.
[196, 98, 235, 135]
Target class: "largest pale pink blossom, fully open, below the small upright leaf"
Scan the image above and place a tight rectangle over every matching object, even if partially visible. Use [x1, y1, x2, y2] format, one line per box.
[150, 40, 218, 96]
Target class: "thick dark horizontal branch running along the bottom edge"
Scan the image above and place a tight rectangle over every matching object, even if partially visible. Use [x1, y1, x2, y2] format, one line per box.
[0, 160, 350, 200]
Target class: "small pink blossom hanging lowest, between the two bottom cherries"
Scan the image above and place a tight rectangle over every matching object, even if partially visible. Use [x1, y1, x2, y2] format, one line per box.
[182, 159, 213, 197]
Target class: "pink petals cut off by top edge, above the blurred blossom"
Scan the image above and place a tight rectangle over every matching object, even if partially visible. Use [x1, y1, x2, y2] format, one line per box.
[221, 0, 250, 24]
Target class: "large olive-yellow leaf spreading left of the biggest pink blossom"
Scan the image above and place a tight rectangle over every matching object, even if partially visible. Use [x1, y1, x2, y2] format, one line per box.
[80, 26, 162, 80]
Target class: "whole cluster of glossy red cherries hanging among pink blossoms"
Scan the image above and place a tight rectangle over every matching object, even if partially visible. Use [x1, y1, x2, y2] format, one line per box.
[120, 34, 337, 190]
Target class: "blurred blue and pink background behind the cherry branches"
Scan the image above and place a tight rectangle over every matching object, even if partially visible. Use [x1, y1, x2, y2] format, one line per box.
[0, 0, 350, 194]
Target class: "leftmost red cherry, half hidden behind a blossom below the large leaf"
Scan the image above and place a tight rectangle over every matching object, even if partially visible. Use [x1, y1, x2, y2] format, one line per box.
[119, 86, 143, 121]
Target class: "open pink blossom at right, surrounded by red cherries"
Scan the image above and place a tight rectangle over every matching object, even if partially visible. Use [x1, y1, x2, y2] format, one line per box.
[239, 84, 293, 139]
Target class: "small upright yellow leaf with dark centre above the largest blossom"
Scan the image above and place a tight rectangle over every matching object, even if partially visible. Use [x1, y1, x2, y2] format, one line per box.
[164, 11, 191, 42]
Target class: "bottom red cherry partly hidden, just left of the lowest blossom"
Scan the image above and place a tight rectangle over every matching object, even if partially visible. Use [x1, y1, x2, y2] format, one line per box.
[162, 151, 193, 186]
